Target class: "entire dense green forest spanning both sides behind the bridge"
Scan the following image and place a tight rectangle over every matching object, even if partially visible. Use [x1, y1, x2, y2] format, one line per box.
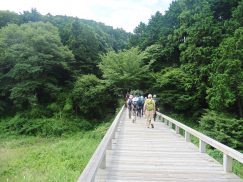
[0, 0, 243, 179]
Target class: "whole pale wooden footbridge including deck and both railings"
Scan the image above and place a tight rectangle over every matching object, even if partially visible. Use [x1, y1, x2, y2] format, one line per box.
[78, 107, 243, 182]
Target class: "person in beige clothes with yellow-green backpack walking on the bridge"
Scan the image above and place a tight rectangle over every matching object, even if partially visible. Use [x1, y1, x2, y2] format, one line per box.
[143, 94, 155, 128]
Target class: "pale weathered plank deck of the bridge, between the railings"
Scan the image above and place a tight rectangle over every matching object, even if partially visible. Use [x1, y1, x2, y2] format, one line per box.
[96, 111, 243, 182]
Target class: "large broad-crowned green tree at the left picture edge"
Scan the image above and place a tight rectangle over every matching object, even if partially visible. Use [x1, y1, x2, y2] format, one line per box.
[0, 22, 73, 108]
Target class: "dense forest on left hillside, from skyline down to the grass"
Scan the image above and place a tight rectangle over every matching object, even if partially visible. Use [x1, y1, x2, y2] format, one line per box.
[0, 9, 130, 132]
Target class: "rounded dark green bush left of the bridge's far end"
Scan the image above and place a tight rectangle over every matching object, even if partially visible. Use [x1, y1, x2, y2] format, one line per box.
[72, 75, 116, 119]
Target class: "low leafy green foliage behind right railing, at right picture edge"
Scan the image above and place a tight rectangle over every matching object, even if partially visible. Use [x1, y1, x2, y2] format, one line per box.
[200, 111, 243, 150]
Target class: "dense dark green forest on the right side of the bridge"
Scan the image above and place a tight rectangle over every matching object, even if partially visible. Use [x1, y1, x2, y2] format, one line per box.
[127, 0, 243, 151]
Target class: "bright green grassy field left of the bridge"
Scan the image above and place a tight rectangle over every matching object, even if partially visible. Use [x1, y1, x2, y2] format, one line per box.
[0, 123, 110, 182]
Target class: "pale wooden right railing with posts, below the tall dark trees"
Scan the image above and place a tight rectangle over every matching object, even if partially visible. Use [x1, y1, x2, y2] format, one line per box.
[157, 112, 243, 172]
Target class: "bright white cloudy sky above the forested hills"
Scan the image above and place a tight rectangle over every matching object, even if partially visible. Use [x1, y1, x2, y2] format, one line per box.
[0, 0, 172, 32]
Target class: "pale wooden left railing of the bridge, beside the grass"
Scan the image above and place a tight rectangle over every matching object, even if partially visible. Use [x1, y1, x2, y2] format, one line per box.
[78, 106, 124, 182]
